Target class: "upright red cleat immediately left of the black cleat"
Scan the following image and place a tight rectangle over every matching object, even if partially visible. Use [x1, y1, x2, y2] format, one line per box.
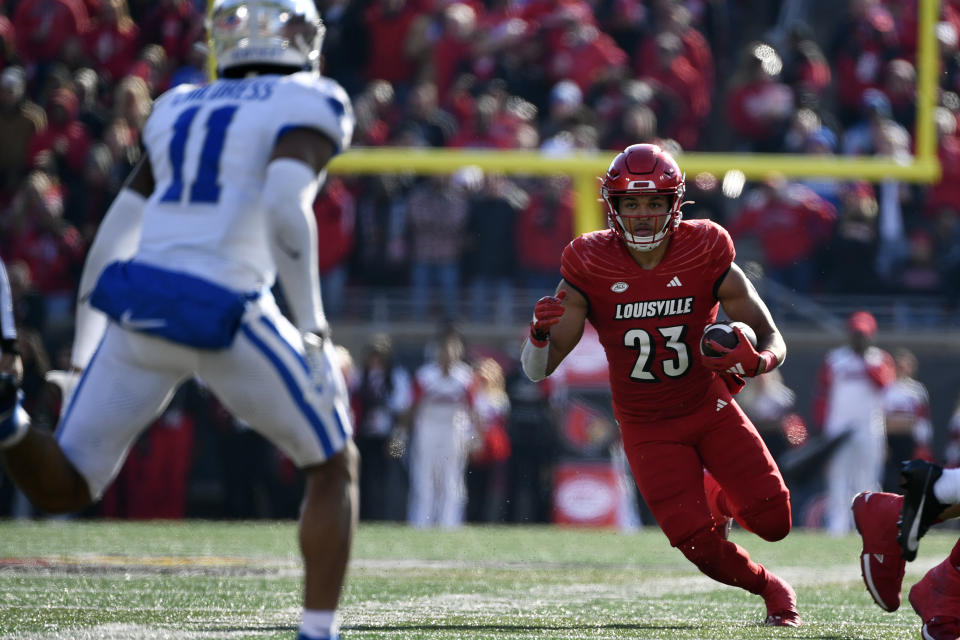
[850, 491, 907, 611]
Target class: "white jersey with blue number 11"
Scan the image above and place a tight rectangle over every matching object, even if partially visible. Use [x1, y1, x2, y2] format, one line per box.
[135, 72, 354, 291]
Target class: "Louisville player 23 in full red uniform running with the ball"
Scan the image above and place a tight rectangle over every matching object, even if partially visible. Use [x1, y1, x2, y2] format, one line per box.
[521, 144, 801, 627]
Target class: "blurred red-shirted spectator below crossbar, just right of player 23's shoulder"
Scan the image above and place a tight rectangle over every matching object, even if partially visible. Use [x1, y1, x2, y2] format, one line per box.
[728, 176, 837, 293]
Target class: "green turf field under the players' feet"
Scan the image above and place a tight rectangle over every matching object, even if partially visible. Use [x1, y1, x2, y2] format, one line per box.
[0, 521, 957, 640]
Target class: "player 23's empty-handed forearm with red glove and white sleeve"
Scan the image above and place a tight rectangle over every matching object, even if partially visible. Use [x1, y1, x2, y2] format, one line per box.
[520, 280, 588, 382]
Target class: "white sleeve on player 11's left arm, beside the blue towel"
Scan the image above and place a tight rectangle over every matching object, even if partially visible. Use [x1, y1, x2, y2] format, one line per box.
[70, 188, 147, 369]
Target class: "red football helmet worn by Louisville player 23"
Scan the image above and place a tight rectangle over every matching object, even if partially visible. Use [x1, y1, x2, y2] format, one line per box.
[600, 144, 687, 251]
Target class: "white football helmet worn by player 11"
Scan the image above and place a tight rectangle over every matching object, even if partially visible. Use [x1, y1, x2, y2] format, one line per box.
[207, 0, 325, 76]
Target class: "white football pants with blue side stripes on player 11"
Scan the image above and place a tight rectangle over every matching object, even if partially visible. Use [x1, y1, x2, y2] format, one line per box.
[56, 294, 352, 500]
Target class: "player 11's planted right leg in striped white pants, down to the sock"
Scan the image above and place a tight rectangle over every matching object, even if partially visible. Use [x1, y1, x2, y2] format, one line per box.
[198, 300, 359, 639]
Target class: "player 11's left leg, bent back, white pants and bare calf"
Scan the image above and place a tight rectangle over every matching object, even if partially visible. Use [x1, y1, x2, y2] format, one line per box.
[0, 325, 183, 513]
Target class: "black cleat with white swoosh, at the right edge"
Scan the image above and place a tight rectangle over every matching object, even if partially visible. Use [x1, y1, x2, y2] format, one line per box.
[897, 460, 947, 561]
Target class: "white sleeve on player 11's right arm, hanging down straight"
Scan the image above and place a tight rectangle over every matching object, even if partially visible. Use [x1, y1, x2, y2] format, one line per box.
[263, 158, 327, 334]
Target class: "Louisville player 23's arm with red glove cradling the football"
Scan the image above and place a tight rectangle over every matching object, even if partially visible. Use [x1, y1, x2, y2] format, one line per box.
[704, 262, 787, 376]
